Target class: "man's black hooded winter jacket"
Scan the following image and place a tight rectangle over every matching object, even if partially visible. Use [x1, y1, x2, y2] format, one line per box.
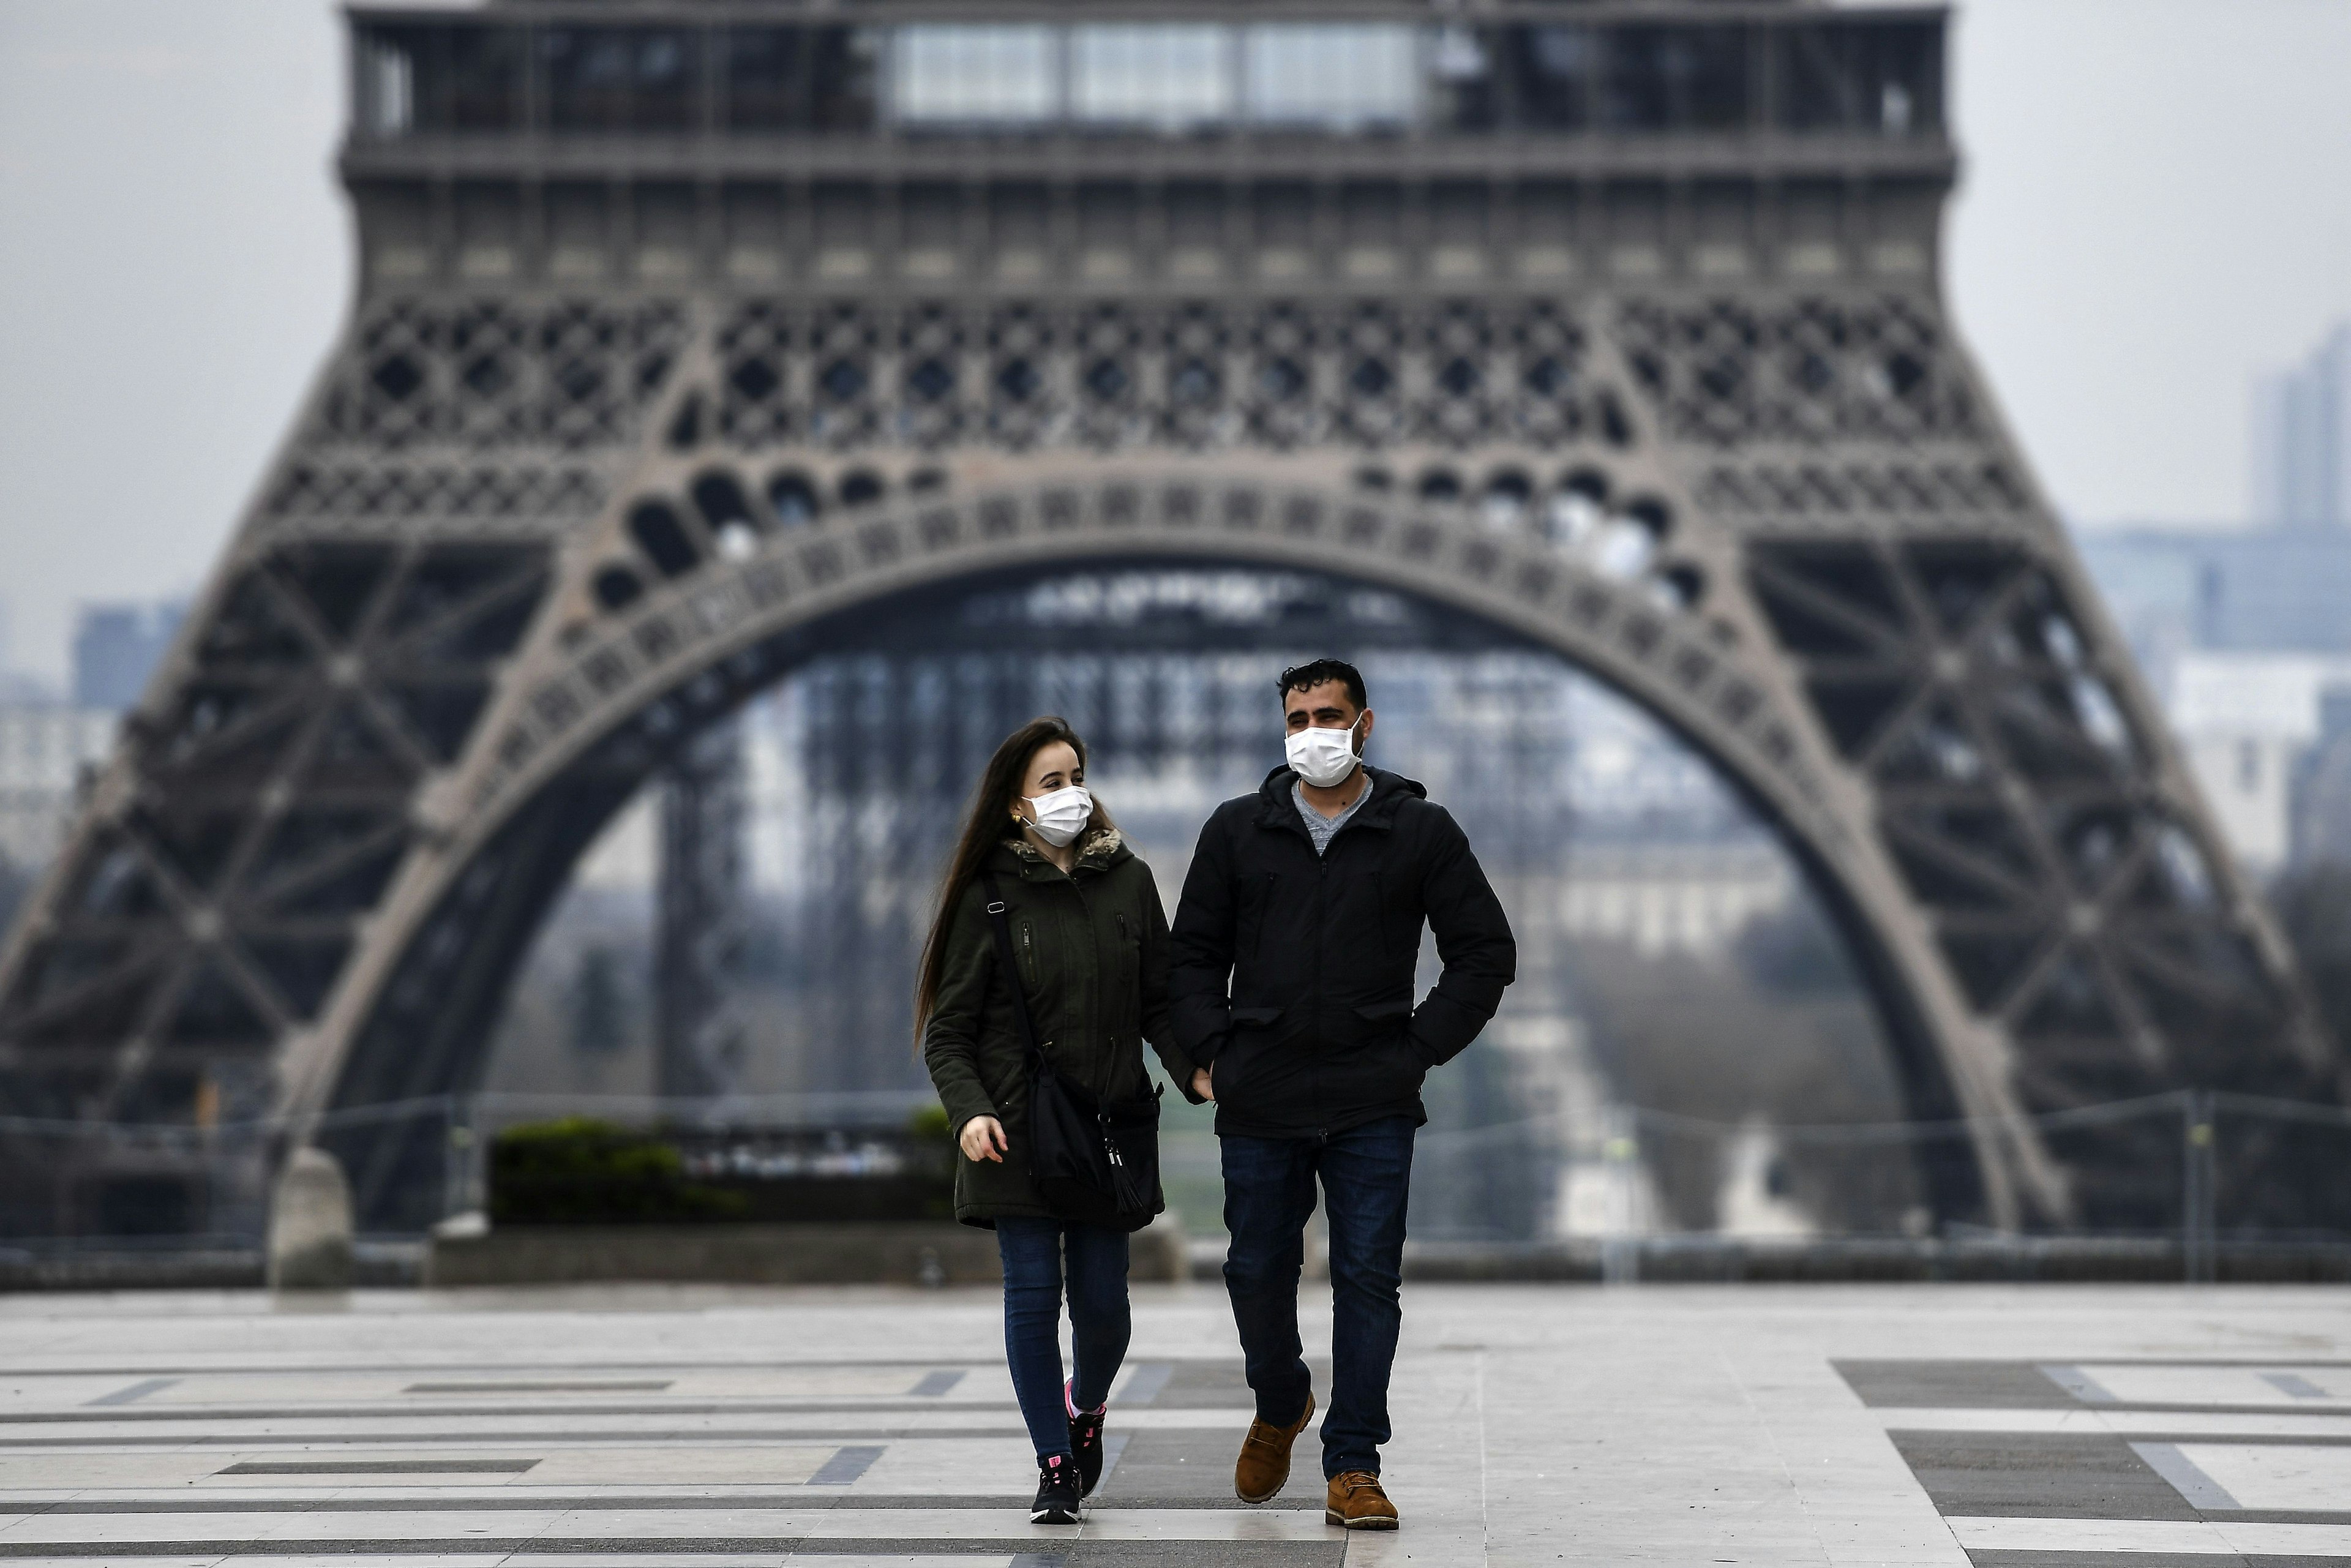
[1168, 767, 1519, 1138]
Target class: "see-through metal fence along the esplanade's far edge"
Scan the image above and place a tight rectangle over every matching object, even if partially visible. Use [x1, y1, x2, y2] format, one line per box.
[0, 1091, 2351, 1281]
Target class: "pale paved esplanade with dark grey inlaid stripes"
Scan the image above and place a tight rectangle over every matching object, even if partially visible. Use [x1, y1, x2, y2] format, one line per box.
[0, 1286, 2351, 1568]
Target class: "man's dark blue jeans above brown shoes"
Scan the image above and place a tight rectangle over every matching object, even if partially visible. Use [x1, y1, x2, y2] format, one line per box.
[1223, 1117, 1415, 1476]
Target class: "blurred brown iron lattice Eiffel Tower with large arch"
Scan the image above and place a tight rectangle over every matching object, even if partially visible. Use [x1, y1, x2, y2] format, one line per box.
[0, 0, 2339, 1227]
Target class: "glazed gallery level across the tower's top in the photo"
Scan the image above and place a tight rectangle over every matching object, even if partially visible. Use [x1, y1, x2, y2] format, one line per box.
[358, 17, 1942, 139]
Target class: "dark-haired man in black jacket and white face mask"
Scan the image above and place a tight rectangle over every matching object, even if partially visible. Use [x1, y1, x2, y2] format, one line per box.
[1168, 658, 1519, 1531]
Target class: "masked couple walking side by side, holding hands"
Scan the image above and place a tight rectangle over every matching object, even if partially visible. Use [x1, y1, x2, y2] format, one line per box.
[915, 658, 1517, 1531]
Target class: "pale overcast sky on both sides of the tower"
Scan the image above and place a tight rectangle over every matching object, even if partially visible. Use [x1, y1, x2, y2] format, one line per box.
[0, 0, 2351, 675]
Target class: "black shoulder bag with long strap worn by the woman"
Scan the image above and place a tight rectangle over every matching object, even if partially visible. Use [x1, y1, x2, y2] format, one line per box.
[985, 874, 1166, 1229]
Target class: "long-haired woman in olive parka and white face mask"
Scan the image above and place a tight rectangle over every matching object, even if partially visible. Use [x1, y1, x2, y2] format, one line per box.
[915, 719, 1192, 1523]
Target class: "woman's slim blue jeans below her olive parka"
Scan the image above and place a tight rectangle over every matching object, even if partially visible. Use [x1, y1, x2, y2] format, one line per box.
[997, 1218, 1128, 1460]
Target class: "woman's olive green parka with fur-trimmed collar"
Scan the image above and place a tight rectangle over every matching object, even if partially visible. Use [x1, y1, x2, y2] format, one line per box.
[921, 828, 1192, 1229]
